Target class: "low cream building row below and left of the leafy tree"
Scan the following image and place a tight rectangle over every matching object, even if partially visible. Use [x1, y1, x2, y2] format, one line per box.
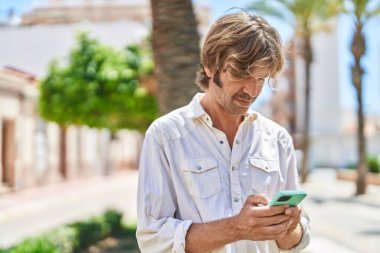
[0, 69, 142, 193]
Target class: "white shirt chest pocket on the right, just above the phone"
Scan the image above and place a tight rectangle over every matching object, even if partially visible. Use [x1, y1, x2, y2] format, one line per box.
[248, 157, 280, 197]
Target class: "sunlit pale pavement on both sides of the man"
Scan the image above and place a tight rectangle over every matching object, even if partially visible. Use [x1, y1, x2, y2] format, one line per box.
[0, 169, 380, 253]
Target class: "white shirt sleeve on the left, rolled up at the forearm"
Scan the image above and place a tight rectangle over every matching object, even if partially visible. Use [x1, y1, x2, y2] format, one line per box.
[136, 127, 192, 253]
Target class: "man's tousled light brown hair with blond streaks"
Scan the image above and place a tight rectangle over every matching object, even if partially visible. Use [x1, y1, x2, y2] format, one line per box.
[196, 11, 284, 90]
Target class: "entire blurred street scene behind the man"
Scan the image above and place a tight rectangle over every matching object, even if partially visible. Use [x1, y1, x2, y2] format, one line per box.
[0, 0, 380, 253]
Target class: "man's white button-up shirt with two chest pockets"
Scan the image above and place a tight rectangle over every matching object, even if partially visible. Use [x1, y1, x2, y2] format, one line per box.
[137, 94, 309, 253]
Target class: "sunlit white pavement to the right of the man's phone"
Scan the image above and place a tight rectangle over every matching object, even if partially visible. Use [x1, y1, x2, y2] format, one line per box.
[301, 169, 380, 253]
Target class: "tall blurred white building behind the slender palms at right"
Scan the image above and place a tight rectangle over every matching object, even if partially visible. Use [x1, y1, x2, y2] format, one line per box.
[296, 17, 380, 167]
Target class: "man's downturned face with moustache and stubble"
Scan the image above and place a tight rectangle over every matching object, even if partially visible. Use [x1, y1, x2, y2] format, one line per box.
[209, 70, 268, 116]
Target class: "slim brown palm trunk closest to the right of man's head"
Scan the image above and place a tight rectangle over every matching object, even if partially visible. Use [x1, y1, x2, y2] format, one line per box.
[301, 32, 313, 183]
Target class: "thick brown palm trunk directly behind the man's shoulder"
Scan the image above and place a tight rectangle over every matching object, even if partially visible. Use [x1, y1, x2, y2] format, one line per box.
[151, 0, 200, 114]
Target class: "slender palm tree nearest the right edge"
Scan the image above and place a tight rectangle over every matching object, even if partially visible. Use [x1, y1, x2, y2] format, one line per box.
[346, 0, 380, 195]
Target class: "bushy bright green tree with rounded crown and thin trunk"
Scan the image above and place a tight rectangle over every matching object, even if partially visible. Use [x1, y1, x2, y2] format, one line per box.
[39, 33, 158, 177]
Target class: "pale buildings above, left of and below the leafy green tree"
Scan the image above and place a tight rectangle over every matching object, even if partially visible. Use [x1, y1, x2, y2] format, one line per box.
[0, 0, 199, 192]
